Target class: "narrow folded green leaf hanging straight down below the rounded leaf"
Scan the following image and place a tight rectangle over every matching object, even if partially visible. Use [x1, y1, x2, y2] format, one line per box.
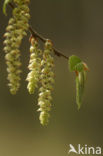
[76, 71, 87, 109]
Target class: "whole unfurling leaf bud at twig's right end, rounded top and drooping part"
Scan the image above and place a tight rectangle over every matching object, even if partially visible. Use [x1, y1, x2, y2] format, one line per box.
[69, 55, 88, 109]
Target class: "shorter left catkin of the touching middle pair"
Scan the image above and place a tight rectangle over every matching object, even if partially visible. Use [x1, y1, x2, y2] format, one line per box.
[26, 37, 42, 94]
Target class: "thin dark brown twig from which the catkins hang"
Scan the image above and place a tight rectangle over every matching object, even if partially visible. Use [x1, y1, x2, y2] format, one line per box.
[9, 3, 69, 60]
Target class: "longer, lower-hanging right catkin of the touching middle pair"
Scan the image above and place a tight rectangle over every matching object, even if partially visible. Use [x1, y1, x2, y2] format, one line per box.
[38, 40, 54, 125]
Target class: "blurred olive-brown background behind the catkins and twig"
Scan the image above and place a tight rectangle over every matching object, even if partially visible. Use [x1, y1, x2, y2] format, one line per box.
[0, 0, 103, 156]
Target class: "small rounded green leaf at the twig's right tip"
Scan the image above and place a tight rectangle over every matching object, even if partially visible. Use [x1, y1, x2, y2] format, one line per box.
[69, 55, 82, 72]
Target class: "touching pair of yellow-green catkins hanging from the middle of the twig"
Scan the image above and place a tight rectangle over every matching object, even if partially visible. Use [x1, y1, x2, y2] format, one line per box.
[26, 37, 54, 125]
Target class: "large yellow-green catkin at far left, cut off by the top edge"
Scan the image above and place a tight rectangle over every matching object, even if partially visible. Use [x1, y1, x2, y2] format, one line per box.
[4, 0, 30, 94]
